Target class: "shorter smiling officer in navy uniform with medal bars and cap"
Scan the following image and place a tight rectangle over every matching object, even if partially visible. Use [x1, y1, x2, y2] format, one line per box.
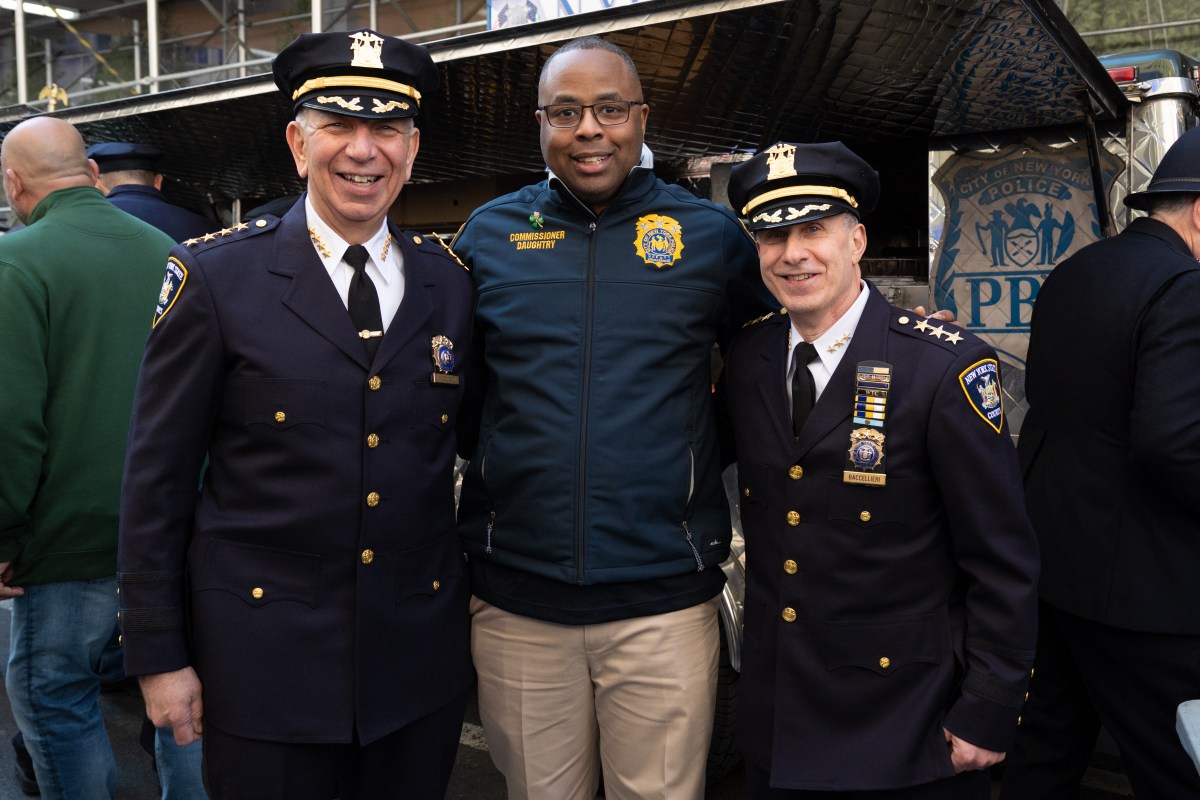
[724, 143, 1038, 800]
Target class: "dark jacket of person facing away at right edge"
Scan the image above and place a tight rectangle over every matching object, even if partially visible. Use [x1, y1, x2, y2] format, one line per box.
[1019, 218, 1200, 634]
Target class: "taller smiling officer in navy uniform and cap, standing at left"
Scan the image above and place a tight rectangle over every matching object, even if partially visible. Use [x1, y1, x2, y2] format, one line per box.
[120, 30, 474, 800]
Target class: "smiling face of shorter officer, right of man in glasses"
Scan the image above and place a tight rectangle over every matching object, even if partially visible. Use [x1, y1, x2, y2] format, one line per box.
[755, 213, 866, 341]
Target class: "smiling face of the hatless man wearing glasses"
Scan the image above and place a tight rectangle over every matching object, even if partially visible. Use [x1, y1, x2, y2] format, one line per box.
[536, 49, 650, 213]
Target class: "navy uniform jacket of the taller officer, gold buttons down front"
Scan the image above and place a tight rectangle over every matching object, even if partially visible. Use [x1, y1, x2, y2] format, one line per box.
[119, 203, 474, 744]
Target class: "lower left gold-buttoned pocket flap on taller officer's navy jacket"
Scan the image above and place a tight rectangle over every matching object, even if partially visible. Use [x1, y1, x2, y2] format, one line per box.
[192, 539, 320, 608]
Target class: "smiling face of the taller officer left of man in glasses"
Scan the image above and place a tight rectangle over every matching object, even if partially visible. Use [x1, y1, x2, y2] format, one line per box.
[287, 108, 420, 245]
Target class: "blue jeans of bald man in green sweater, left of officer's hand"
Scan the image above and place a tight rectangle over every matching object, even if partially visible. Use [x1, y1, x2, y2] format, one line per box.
[5, 576, 121, 800]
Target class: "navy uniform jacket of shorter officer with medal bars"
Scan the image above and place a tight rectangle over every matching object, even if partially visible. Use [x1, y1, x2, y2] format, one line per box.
[726, 288, 1038, 790]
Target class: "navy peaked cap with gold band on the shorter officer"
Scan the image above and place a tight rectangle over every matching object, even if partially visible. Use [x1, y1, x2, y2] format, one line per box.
[730, 142, 880, 230]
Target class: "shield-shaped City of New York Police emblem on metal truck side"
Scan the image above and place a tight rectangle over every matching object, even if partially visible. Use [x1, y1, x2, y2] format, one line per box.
[932, 140, 1120, 365]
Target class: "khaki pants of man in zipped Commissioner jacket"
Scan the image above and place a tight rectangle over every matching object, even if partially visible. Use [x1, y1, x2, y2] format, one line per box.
[470, 597, 720, 800]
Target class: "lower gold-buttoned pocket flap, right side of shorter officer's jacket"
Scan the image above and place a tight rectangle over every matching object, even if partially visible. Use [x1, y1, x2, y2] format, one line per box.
[826, 614, 941, 675]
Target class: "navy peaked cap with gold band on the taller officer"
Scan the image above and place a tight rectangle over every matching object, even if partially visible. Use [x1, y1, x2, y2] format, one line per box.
[272, 29, 438, 119]
